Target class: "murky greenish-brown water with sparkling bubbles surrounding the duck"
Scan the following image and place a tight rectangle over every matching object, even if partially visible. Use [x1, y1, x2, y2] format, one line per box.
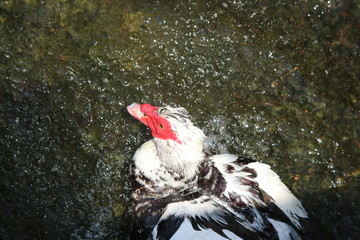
[0, 0, 360, 240]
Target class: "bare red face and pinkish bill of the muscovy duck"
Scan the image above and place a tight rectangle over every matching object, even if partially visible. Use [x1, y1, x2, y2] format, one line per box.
[127, 103, 181, 143]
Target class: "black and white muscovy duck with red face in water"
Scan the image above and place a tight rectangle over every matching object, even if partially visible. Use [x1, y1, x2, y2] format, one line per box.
[127, 103, 312, 240]
